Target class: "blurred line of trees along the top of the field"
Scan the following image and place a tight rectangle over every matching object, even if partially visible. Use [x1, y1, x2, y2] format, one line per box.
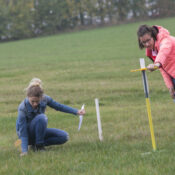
[0, 0, 175, 41]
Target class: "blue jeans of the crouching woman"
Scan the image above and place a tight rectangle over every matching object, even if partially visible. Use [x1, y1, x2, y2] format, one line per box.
[28, 114, 69, 146]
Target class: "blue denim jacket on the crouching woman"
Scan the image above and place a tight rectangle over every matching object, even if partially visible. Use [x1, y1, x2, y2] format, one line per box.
[16, 95, 78, 152]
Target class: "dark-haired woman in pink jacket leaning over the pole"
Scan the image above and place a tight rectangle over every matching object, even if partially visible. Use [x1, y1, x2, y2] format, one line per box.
[137, 25, 175, 99]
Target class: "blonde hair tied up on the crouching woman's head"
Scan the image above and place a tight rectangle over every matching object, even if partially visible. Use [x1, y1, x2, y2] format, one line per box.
[25, 78, 44, 98]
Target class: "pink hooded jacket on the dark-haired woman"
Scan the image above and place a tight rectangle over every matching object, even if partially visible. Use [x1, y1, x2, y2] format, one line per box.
[146, 26, 175, 88]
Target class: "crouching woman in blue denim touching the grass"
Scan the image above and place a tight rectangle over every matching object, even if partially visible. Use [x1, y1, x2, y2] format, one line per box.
[16, 78, 85, 156]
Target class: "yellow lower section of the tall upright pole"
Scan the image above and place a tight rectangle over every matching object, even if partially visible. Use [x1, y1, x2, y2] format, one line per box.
[146, 98, 156, 151]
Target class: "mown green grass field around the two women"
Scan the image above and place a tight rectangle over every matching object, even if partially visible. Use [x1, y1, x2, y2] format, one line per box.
[0, 18, 175, 175]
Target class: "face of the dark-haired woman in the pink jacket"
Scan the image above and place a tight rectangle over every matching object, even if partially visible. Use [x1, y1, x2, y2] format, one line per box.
[140, 33, 154, 50]
